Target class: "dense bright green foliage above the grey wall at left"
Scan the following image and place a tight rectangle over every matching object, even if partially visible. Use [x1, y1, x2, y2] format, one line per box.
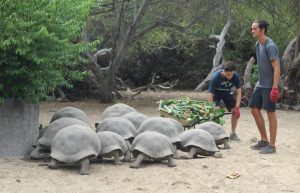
[0, 0, 92, 102]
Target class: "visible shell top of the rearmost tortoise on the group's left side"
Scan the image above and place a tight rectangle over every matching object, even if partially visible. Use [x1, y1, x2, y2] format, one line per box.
[50, 107, 92, 128]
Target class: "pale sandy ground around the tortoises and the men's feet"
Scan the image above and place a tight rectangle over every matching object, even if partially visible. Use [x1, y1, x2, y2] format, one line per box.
[0, 92, 300, 193]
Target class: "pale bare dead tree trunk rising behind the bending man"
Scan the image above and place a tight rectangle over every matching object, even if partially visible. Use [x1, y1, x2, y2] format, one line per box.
[195, 7, 232, 91]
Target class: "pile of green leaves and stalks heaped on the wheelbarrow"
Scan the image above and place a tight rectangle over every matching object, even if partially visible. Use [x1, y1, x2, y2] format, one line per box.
[159, 98, 225, 126]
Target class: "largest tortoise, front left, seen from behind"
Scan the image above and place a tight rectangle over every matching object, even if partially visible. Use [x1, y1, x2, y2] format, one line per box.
[49, 125, 101, 175]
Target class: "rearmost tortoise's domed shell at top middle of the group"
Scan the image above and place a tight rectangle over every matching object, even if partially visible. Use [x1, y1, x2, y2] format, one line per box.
[95, 103, 137, 128]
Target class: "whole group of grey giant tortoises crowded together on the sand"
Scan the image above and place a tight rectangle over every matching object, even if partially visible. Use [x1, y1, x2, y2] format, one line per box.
[31, 103, 230, 175]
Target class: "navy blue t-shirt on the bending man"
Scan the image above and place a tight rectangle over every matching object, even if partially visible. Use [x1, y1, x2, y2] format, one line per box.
[208, 70, 241, 96]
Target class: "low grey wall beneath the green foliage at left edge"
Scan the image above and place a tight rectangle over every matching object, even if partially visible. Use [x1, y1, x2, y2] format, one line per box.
[0, 100, 39, 157]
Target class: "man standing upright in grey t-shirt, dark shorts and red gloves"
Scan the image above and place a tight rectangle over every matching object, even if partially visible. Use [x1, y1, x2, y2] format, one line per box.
[249, 19, 280, 154]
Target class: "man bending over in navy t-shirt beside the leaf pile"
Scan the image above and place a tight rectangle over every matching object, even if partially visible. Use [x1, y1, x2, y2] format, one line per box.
[208, 61, 242, 141]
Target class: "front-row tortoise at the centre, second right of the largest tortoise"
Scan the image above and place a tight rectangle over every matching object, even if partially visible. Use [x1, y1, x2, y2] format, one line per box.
[130, 131, 176, 168]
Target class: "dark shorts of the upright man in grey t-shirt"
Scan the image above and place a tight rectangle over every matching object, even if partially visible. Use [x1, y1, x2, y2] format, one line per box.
[249, 87, 276, 112]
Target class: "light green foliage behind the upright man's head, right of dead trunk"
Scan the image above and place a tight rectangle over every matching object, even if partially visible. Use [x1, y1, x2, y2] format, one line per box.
[230, 0, 298, 55]
